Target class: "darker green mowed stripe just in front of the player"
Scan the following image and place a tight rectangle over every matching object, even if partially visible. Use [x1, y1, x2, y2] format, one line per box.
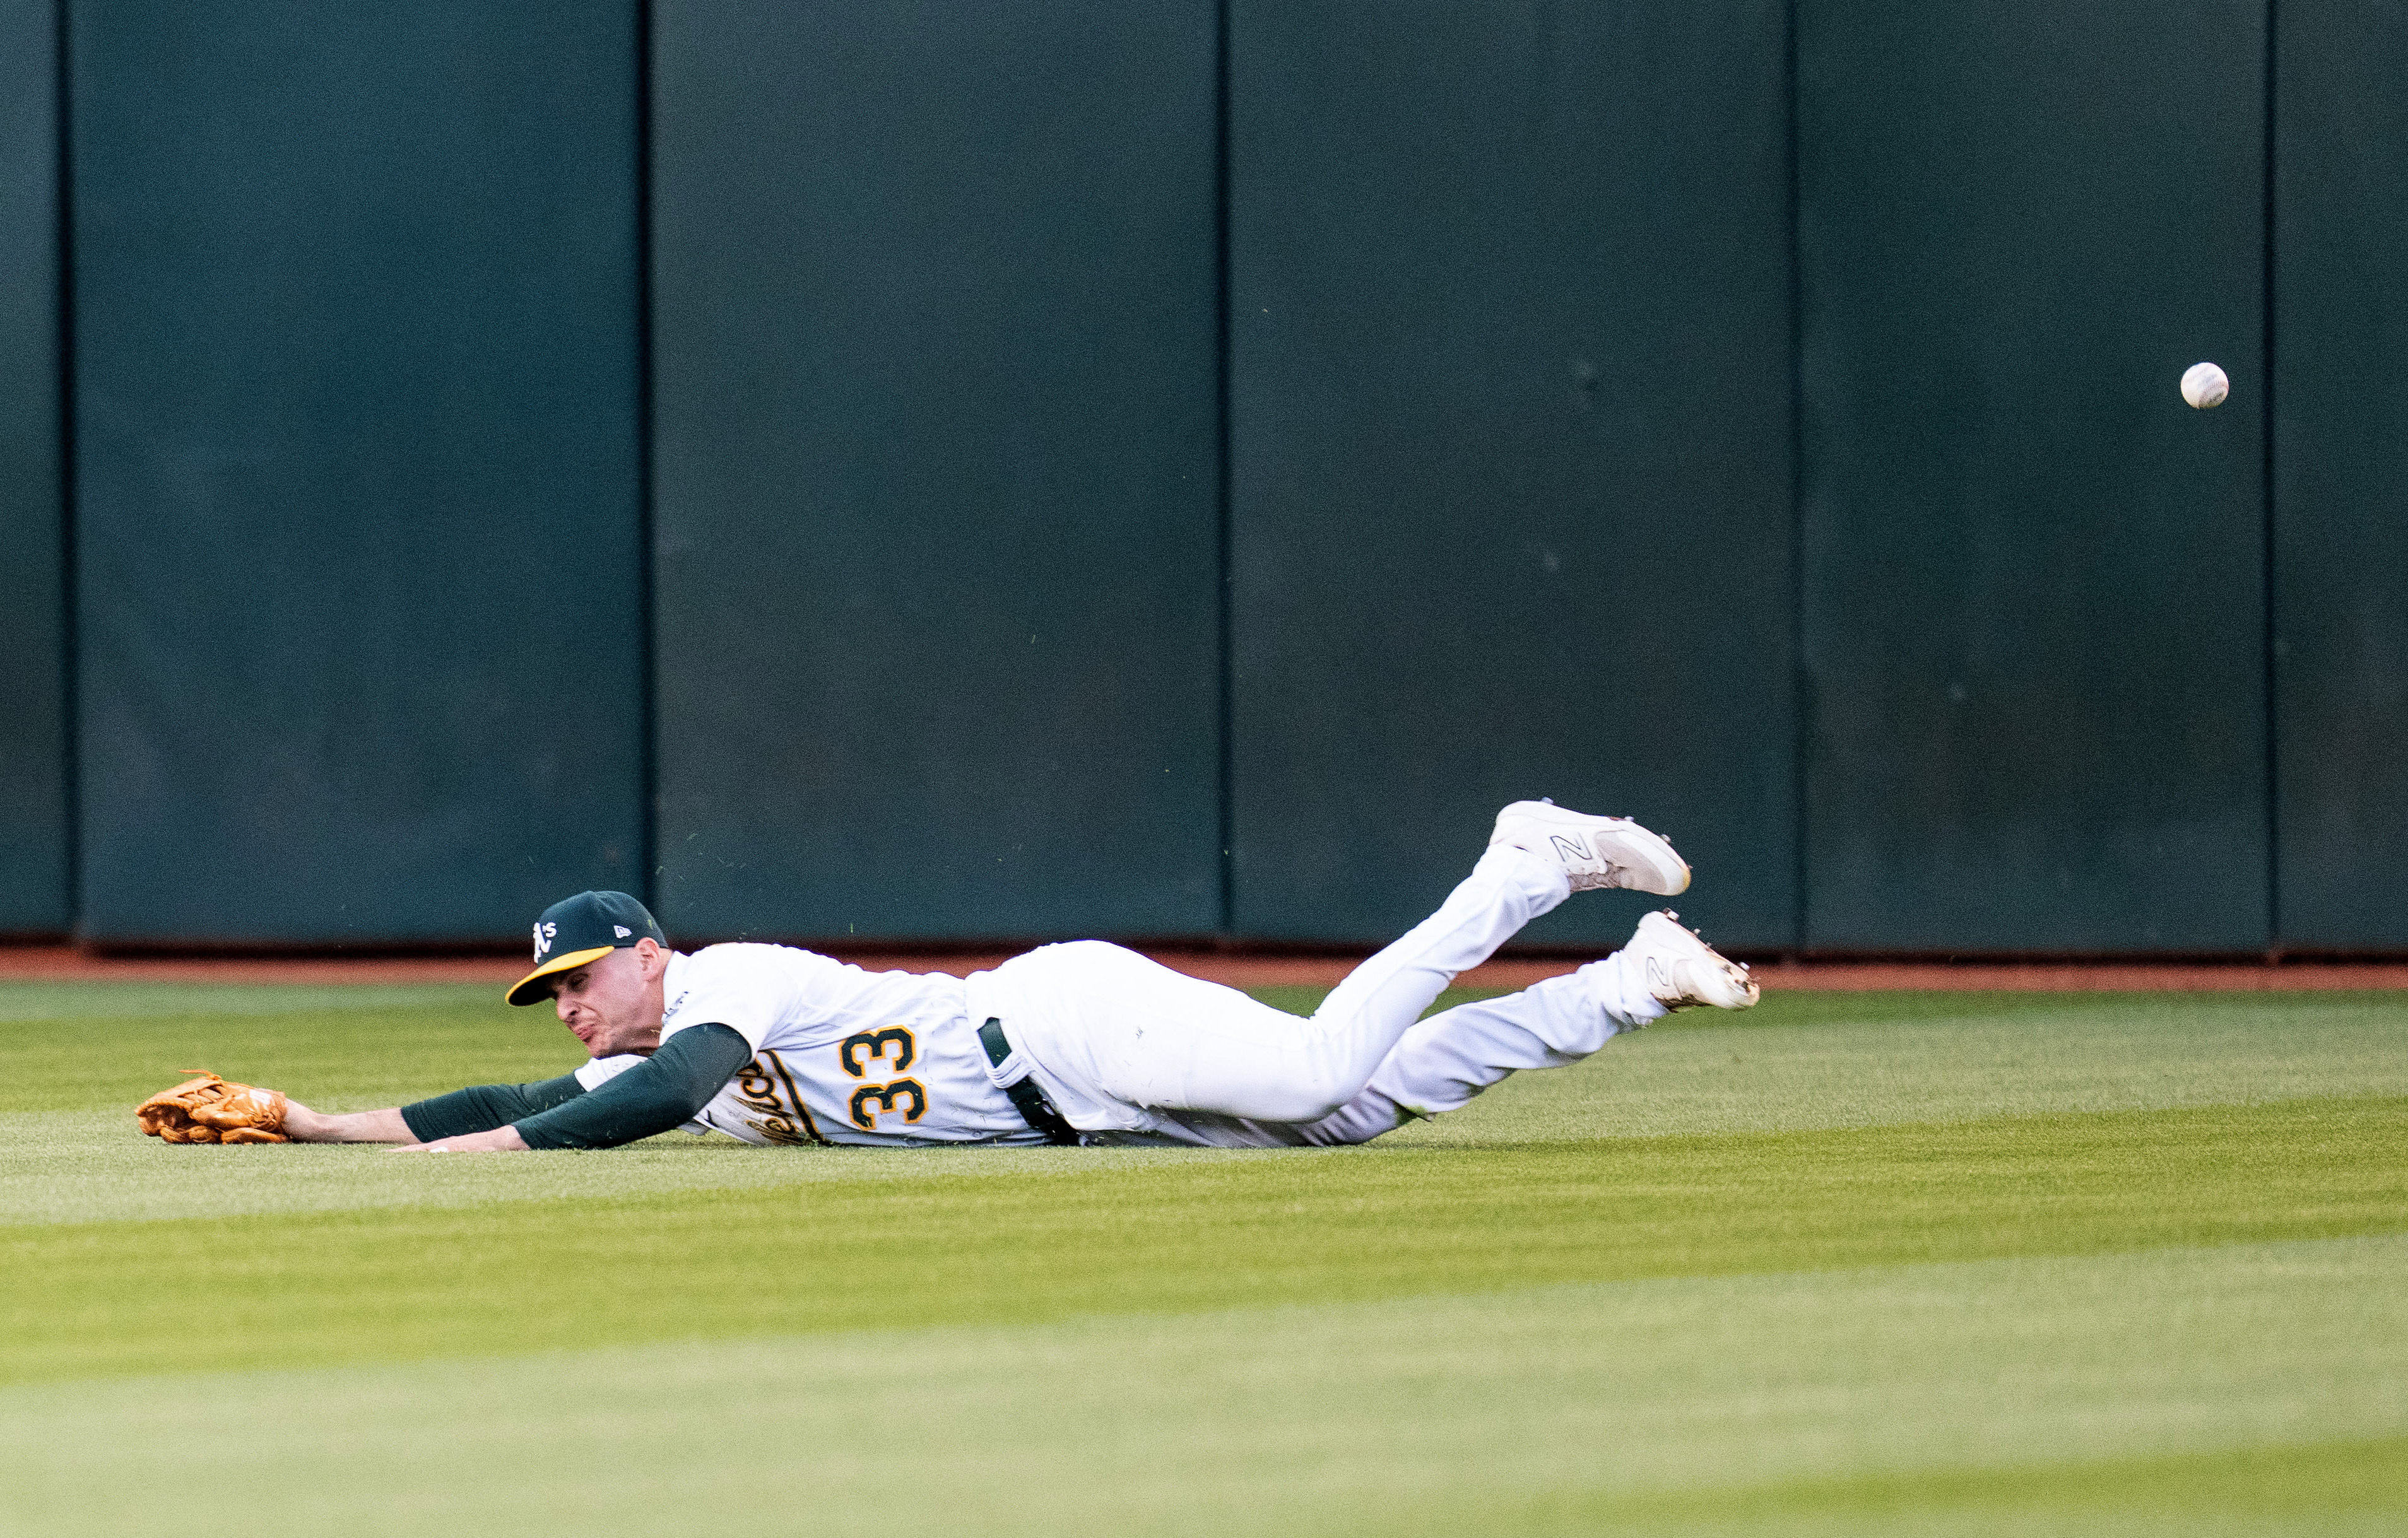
[0, 1098, 2408, 1382]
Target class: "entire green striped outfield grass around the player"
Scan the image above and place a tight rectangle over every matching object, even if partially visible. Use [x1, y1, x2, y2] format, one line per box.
[0, 984, 2408, 1538]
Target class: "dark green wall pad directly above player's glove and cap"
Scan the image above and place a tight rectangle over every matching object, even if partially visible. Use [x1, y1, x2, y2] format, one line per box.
[70, 0, 646, 941]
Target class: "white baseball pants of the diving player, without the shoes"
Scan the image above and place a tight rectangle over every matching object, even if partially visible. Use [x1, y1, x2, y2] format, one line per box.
[968, 850, 1664, 1148]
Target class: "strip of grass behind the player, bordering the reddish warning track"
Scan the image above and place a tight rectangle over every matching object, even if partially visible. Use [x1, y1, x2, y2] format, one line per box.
[0, 987, 2408, 1141]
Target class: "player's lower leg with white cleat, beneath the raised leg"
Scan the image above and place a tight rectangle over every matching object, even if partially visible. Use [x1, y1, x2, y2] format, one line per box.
[1276, 912, 1756, 1143]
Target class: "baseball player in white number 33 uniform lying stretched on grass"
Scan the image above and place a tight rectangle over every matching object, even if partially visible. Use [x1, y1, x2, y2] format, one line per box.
[138, 802, 1756, 1153]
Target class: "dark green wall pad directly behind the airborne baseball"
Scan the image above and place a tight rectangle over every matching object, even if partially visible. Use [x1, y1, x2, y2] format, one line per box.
[1799, 0, 2269, 951]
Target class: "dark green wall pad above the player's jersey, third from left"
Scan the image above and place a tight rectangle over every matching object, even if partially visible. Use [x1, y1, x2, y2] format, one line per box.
[652, 0, 1221, 941]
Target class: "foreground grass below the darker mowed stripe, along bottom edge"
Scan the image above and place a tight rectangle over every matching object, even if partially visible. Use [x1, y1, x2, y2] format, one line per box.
[0, 1237, 2408, 1535]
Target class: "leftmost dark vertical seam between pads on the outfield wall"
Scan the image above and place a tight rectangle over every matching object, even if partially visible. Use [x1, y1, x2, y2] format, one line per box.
[50, 0, 85, 934]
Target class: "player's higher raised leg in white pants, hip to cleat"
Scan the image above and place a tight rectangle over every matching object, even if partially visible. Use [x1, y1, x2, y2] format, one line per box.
[1000, 802, 1688, 1127]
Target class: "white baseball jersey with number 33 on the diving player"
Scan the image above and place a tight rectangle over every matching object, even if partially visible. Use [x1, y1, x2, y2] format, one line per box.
[578, 946, 1045, 1148]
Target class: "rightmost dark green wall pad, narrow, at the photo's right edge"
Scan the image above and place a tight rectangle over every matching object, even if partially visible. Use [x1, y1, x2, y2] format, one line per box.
[2273, 0, 2408, 951]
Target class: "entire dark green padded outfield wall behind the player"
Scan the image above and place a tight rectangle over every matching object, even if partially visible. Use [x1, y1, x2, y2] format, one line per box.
[0, 0, 2408, 956]
